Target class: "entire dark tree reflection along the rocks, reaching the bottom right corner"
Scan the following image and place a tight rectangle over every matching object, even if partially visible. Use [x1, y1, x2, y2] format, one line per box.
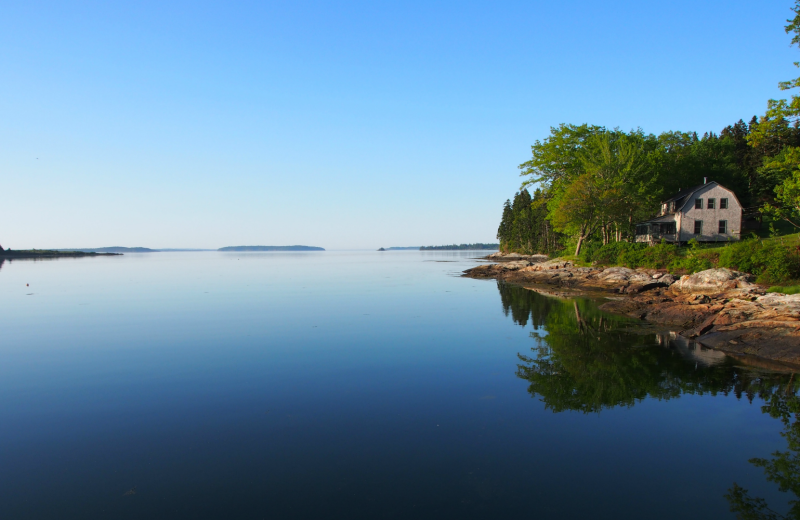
[498, 282, 800, 520]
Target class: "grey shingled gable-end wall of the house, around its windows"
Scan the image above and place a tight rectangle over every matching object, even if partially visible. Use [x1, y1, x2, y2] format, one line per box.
[676, 183, 742, 242]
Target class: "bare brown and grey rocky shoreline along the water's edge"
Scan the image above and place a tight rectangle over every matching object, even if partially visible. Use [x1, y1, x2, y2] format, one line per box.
[464, 253, 800, 366]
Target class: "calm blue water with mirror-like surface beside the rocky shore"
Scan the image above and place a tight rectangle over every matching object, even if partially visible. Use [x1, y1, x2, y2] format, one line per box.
[0, 251, 800, 519]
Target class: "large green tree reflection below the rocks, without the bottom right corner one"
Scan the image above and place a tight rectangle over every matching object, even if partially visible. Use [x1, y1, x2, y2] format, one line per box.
[498, 283, 758, 413]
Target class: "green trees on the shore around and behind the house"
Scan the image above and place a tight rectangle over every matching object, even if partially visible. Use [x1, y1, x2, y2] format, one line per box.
[497, 0, 800, 255]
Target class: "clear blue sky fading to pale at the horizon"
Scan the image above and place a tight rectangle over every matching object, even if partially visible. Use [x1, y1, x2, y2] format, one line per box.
[0, 0, 800, 249]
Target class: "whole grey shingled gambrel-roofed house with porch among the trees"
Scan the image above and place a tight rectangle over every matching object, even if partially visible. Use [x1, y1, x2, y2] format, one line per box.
[636, 181, 742, 243]
